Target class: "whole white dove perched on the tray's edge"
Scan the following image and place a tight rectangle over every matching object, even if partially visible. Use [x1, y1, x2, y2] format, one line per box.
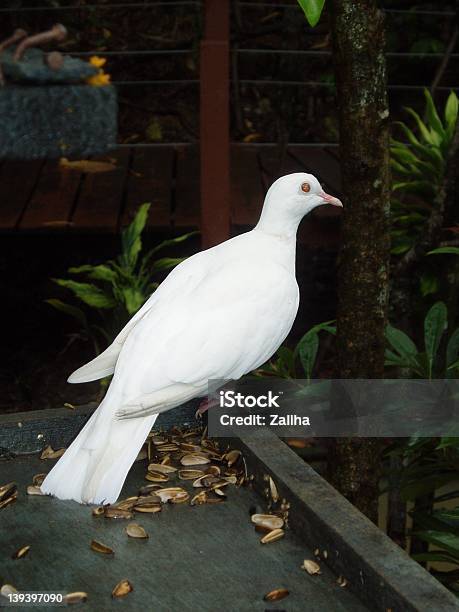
[41, 172, 342, 504]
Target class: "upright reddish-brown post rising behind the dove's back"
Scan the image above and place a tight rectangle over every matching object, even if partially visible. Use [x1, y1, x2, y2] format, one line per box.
[200, 0, 231, 248]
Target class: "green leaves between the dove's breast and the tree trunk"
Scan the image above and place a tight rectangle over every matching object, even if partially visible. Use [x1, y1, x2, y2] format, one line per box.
[254, 321, 336, 381]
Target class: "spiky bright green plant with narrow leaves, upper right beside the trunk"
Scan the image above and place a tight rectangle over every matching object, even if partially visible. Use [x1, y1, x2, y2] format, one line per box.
[391, 89, 458, 255]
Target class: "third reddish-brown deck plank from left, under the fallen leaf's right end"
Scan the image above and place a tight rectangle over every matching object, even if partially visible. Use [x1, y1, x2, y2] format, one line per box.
[71, 149, 130, 232]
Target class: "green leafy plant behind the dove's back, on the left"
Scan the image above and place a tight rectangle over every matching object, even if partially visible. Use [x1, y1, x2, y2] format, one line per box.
[47, 203, 196, 352]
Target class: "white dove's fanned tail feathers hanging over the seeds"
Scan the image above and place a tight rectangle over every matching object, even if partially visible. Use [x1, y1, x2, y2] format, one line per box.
[41, 398, 157, 504]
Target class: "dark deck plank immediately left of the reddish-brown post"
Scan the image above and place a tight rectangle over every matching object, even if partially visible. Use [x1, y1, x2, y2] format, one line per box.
[173, 147, 200, 228]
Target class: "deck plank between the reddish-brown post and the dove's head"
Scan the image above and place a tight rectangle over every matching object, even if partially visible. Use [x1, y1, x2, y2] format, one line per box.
[231, 147, 264, 225]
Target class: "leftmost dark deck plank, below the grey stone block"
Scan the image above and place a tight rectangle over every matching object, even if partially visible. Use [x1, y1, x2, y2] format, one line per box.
[0, 160, 43, 230]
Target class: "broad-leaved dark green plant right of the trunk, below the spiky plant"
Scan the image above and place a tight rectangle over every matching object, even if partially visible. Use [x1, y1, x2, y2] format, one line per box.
[385, 302, 459, 380]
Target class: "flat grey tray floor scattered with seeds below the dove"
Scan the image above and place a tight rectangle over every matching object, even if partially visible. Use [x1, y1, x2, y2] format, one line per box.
[0, 456, 368, 612]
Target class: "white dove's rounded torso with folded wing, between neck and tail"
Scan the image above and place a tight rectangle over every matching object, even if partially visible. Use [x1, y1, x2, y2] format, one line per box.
[112, 231, 299, 404]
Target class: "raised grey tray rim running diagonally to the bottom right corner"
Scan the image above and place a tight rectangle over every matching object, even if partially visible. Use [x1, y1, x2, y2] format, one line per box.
[230, 430, 459, 612]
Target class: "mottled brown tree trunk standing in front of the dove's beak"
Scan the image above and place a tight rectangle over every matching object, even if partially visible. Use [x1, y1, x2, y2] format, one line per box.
[329, 0, 390, 522]
